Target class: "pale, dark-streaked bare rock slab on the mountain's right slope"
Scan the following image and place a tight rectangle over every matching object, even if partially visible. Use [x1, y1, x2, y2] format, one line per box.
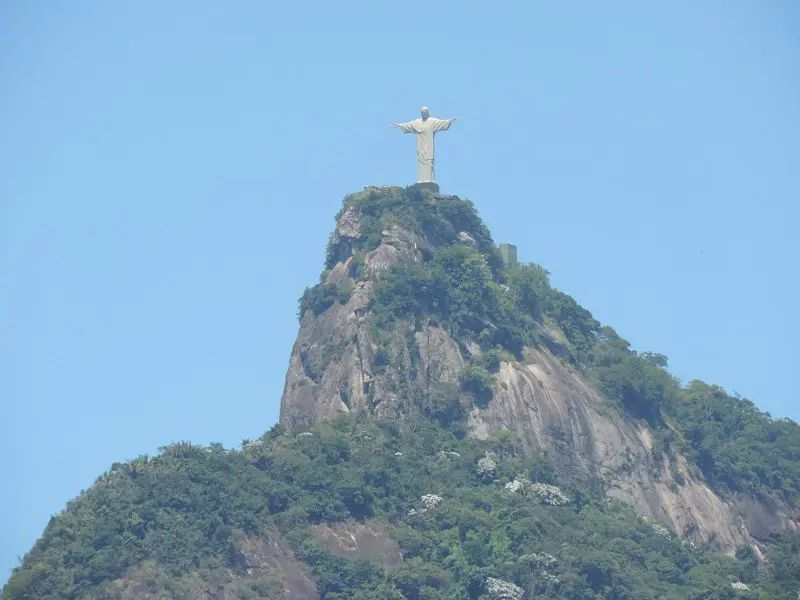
[470, 349, 750, 550]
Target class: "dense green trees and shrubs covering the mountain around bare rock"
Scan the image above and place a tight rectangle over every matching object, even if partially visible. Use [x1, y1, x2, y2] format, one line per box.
[3, 187, 800, 600]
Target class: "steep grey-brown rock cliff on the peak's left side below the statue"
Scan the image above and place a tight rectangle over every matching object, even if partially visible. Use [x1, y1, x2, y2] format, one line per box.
[280, 188, 432, 428]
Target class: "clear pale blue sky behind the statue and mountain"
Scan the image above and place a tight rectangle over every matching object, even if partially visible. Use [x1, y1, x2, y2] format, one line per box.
[0, 0, 800, 581]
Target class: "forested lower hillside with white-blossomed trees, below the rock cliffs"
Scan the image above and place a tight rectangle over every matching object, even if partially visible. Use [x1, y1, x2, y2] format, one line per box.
[3, 415, 800, 600]
